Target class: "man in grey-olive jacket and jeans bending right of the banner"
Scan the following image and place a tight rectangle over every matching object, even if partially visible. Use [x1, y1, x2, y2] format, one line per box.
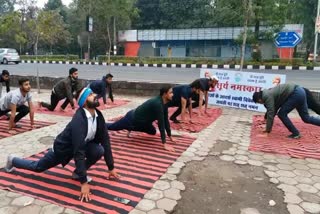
[252, 84, 320, 139]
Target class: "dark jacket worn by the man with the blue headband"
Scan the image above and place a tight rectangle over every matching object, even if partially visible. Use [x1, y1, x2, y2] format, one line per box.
[53, 108, 114, 183]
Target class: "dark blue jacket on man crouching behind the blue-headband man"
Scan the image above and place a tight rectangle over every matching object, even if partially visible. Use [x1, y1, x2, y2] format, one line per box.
[90, 76, 113, 104]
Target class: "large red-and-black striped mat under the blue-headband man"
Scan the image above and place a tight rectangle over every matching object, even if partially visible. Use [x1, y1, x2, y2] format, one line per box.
[0, 132, 195, 214]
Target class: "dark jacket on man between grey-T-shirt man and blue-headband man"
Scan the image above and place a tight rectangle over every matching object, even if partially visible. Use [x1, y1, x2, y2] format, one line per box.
[53, 76, 80, 107]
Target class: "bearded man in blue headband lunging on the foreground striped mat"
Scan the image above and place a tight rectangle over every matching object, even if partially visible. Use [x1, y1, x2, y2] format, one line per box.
[5, 88, 120, 201]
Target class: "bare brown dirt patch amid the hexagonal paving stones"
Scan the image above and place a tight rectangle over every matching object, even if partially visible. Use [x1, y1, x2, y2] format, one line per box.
[174, 143, 288, 214]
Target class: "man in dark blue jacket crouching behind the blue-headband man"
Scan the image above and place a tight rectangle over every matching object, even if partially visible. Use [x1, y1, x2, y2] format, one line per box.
[89, 74, 114, 105]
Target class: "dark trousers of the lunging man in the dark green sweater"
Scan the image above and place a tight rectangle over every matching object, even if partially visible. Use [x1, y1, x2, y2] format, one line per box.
[106, 110, 157, 135]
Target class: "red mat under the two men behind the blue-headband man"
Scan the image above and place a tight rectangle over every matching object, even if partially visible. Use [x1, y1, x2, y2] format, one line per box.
[35, 99, 130, 117]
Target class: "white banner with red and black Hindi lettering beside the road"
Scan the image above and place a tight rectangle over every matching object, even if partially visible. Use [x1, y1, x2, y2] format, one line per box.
[200, 69, 286, 112]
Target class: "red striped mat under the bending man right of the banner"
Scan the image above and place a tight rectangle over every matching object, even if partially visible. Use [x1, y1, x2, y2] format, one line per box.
[249, 116, 320, 159]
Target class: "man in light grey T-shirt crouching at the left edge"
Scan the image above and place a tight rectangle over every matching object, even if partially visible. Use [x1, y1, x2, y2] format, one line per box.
[0, 78, 35, 134]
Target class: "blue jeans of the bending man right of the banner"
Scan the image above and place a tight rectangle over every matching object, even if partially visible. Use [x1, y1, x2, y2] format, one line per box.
[278, 86, 320, 135]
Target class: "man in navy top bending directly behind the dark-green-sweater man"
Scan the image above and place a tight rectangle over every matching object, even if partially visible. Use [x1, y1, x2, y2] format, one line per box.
[167, 85, 200, 123]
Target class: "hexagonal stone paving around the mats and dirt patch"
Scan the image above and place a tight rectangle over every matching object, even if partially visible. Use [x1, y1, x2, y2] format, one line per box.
[0, 91, 320, 214]
